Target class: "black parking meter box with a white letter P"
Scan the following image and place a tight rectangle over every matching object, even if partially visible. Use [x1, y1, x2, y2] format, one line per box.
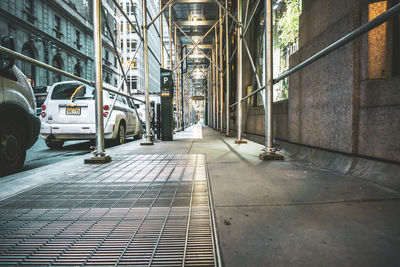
[160, 69, 174, 141]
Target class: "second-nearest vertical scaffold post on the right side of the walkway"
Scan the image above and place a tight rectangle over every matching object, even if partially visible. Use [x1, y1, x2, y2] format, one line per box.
[235, 0, 247, 144]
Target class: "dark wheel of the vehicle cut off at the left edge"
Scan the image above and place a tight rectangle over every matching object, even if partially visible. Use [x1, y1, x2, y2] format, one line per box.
[0, 121, 26, 175]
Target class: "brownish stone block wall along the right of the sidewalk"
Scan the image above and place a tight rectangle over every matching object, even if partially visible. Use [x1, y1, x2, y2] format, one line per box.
[239, 0, 400, 162]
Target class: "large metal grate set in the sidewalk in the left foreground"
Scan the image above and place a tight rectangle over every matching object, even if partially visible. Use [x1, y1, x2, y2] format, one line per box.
[0, 154, 217, 266]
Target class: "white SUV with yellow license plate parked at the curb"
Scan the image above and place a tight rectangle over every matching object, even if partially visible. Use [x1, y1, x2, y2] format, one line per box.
[40, 81, 142, 149]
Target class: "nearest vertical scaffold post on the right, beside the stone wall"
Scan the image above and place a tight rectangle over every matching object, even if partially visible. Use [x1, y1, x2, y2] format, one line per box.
[258, 0, 283, 160]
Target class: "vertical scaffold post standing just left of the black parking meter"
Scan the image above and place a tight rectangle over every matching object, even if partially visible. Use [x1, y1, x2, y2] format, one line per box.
[141, 0, 153, 145]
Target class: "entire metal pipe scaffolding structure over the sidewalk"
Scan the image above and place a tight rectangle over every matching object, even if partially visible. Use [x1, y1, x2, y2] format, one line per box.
[0, 0, 400, 162]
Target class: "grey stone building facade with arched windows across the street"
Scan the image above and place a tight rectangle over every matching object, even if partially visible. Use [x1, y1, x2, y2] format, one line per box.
[0, 0, 120, 90]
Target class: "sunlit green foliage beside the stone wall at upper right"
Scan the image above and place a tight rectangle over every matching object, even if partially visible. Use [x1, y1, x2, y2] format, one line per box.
[276, 0, 301, 48]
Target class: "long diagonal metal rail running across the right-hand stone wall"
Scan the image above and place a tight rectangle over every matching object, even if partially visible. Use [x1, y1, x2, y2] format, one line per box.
[230, 4, 400, 107]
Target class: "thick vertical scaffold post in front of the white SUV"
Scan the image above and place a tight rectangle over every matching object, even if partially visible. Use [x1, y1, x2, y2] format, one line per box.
[84, 0, 111, 163]
